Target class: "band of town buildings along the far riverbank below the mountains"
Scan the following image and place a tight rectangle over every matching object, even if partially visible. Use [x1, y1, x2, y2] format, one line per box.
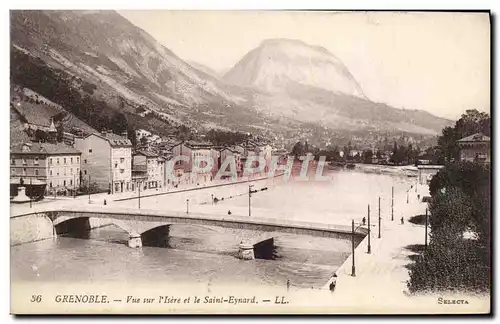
[11, 80, 472, 197]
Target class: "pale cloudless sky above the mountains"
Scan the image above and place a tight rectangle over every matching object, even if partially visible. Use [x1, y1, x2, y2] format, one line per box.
[119, 10, 490, 120]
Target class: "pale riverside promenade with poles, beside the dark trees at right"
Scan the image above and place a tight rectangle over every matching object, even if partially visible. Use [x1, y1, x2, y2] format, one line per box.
[324, 185, 489, 314]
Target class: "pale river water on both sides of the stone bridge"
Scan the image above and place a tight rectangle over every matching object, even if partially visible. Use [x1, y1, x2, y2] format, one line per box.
[11, 170, 414, 288]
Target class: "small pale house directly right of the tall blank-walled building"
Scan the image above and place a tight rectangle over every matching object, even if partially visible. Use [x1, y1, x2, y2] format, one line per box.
[132, 151, 165, 190]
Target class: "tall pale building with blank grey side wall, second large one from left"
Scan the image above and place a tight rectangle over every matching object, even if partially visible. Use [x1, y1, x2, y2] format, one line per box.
[75, 132, 132, 193]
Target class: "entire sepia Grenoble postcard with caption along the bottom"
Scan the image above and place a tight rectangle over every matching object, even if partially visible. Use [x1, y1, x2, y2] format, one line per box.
[9, 10, 492, 315]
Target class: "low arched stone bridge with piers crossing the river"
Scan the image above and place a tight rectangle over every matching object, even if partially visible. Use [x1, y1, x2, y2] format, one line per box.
[11, 205, 367, 259]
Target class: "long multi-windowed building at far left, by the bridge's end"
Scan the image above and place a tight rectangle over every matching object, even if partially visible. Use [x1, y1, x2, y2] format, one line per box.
[10, 143, 81, 195]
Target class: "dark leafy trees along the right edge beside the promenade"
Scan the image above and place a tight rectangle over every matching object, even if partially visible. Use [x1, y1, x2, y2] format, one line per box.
[408, 110, 491, 292]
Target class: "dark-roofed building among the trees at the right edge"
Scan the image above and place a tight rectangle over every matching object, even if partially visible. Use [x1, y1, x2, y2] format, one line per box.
[458, 133, 491, 164]
